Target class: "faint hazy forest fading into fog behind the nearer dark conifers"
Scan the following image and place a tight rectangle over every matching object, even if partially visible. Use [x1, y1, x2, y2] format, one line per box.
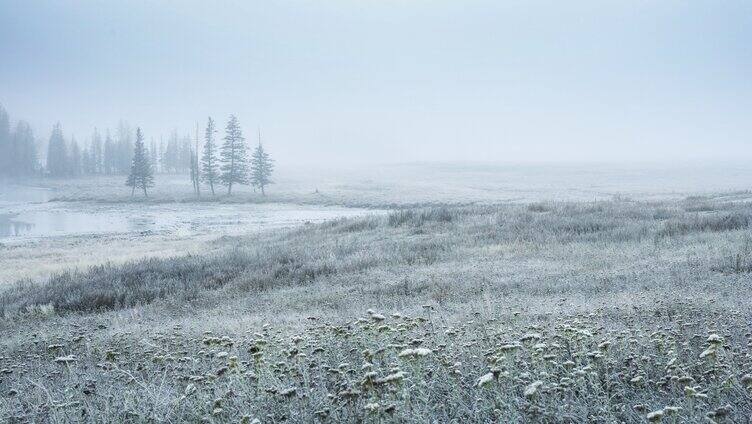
[0, 105, 201, 178]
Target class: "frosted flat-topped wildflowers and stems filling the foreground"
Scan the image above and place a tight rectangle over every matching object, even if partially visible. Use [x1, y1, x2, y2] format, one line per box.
[0, 305, 752, 423]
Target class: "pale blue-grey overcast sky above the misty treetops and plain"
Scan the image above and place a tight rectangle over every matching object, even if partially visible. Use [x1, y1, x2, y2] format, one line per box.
[0, 0, 752, 164]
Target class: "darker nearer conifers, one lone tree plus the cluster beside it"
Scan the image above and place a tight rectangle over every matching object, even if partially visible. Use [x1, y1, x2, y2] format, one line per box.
[131, 115, 274, 196]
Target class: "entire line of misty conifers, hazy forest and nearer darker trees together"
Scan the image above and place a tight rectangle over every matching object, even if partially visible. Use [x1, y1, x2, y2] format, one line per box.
[0, 105, 274, 199]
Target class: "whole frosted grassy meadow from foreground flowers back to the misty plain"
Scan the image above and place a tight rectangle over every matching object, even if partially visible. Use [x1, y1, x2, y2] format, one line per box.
[0, 198, 752, 422]
